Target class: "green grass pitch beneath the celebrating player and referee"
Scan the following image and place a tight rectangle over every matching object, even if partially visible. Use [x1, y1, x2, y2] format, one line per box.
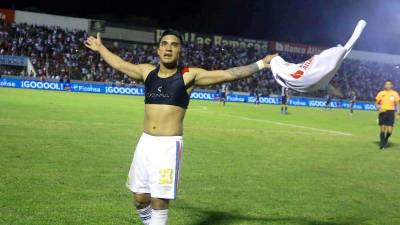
[0, 88, 400, 225]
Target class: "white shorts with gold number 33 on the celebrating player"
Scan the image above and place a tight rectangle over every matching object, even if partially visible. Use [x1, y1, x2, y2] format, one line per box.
[126, 133, 183, 199]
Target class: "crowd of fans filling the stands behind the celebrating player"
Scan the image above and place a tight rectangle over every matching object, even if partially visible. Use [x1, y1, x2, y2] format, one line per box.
[0, 21, 400, 100]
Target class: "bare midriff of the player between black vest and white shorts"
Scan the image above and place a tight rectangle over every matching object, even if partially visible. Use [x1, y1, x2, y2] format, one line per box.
[144, 104, 186, 136]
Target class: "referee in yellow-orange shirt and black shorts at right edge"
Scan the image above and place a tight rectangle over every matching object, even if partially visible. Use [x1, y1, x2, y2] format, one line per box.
[375, 80, 400, 150]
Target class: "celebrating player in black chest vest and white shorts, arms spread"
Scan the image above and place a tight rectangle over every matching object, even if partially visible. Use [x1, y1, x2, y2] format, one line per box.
[85, 30, 276, 225]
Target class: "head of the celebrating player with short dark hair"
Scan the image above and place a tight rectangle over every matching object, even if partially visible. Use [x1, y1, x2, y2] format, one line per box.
[157, 35, 181, 66]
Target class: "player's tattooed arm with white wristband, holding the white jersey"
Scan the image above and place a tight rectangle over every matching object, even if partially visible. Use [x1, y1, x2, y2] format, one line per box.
[192, 54, 276, 86]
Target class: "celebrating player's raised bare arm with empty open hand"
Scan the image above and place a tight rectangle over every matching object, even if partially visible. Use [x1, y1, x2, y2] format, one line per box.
[85, 33, 154, 80]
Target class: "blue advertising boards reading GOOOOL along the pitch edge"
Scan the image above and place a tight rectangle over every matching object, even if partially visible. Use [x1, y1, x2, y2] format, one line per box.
[0, 78, 376, 111]
